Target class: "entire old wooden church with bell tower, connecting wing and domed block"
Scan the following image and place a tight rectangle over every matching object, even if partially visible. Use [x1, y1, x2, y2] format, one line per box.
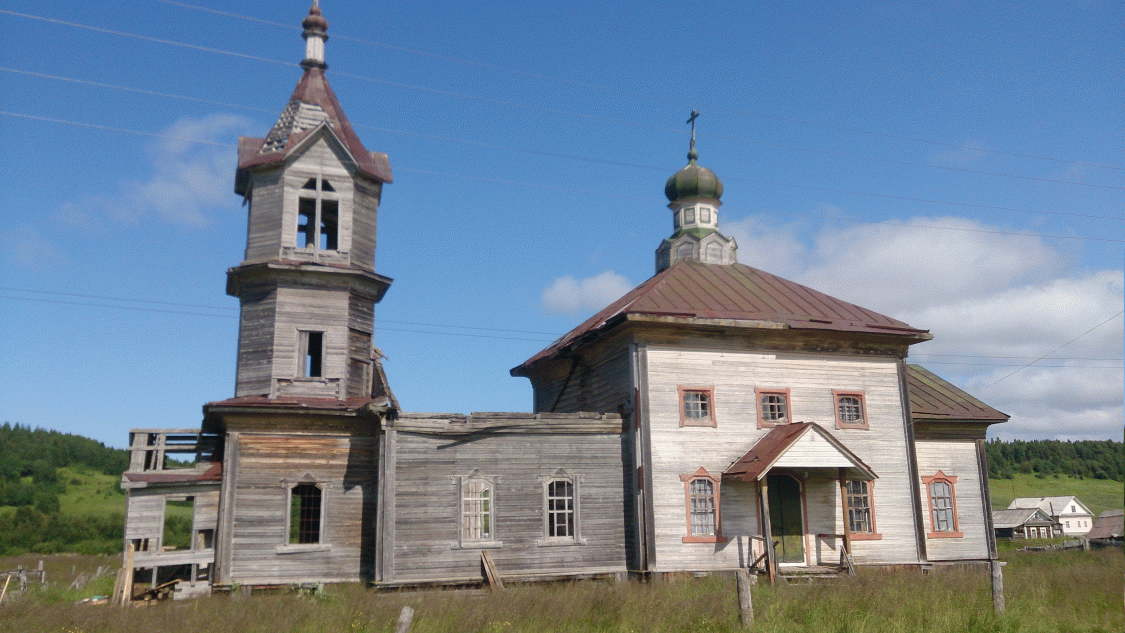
[122, 1, 1007, 595]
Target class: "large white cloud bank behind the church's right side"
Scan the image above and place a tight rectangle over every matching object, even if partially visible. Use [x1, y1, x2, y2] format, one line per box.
[726, 209, 1125, 440]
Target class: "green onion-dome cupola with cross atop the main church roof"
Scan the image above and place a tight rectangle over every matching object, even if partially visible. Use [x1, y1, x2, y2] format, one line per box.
[656, 110, 738, 272]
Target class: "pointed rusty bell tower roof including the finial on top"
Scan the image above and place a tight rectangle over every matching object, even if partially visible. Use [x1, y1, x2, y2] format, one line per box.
[234, 0, 393, 195]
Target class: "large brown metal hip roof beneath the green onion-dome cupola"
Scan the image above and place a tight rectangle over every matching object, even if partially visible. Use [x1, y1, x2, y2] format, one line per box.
[512, 260, 929, 376]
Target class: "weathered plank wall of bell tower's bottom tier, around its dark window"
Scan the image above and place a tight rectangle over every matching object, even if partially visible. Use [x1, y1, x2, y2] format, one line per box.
[224, 433, 378, 585]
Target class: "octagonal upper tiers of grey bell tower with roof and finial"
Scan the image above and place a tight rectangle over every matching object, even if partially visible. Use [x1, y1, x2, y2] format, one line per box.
[226, 0, 392, 400]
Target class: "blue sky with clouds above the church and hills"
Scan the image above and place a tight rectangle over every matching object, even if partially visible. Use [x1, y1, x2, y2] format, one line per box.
[0, 0, 1125, 446]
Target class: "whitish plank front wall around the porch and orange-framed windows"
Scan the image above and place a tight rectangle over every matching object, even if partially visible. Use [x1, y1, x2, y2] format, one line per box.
[645, 345, 919, 571]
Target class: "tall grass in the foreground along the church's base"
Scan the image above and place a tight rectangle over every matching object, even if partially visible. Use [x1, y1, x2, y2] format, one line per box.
[0, 550, 1125, 633]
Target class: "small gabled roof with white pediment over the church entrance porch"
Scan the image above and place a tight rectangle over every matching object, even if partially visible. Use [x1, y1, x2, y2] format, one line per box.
[722, 422, 879, 481]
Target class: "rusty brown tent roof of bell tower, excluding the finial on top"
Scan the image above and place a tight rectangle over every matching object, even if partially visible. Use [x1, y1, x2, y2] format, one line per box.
[235, 66, 393, 193]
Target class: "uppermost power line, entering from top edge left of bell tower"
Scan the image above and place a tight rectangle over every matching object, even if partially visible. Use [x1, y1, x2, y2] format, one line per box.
[156, 0, 1125, 171]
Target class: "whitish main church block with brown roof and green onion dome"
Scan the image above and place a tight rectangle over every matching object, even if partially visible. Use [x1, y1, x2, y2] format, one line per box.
[512, 116, 1007, 573]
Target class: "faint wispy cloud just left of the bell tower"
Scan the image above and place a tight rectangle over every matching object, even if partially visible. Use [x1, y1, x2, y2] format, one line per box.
[55, 115, 249, 226]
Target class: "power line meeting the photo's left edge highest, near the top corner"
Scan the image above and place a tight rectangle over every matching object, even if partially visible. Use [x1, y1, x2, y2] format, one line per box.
[0, 9, 1125, 190]
